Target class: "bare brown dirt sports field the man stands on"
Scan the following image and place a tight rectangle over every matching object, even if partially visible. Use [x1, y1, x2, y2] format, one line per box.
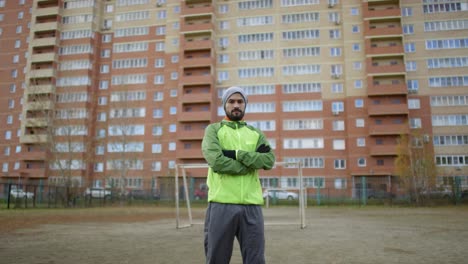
[0, 206, 468, 264]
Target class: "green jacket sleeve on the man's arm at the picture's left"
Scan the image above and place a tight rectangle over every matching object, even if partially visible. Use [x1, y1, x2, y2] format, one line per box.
[202, 124, 252, 175]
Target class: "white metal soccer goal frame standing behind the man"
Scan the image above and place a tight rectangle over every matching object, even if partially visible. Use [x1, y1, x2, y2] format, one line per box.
[174, 162, 307, 229]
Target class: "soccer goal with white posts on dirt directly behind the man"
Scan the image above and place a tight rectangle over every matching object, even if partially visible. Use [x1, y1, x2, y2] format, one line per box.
[175, 162, 307, 229]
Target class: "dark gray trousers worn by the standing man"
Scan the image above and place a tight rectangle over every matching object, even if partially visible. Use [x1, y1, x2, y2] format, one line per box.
[205, 202, 265, 264]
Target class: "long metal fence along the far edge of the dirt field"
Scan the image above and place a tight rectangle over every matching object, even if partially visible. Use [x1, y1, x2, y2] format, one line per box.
[0, 177, 468, 209]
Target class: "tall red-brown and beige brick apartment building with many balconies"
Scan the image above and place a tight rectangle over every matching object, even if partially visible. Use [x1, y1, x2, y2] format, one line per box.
[0, 0, 468, 195]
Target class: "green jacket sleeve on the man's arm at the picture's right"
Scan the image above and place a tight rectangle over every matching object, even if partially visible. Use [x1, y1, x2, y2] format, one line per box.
[236, 130, 276, 170]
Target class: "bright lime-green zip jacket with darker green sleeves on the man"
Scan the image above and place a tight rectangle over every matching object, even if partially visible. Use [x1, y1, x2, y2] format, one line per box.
[202, 120, 275, 205]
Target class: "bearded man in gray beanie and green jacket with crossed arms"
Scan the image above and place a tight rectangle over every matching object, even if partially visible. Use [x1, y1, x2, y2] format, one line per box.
[202, 86, 275, 264]
